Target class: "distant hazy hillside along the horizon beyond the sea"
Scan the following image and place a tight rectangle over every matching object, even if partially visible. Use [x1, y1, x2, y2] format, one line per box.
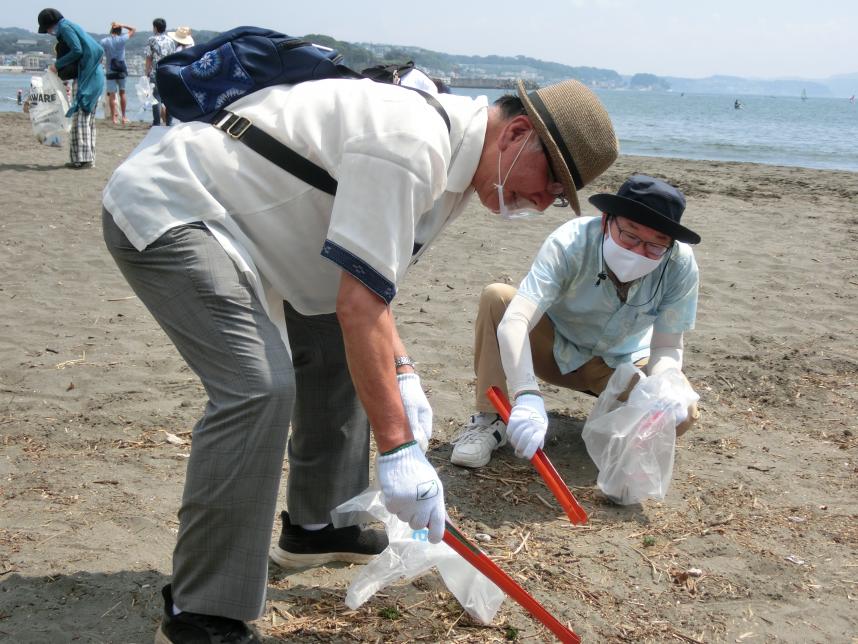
[0, 25, 858, 97]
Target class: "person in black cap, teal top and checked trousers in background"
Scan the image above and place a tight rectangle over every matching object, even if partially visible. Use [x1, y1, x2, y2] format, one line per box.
[38, 9, 104, 169]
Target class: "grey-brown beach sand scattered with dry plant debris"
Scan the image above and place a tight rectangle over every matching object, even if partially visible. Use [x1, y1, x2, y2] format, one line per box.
[0, 114, 858, 642]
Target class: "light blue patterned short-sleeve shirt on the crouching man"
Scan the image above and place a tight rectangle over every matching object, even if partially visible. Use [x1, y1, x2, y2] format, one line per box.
[518, 217, 698, 373]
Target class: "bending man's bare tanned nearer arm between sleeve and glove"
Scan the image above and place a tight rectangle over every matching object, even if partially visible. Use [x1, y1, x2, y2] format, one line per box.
[337, 273, 413, 453]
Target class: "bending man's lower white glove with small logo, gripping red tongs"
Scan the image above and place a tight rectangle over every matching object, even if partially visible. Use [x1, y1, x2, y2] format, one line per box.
[376, 443, 447, 543]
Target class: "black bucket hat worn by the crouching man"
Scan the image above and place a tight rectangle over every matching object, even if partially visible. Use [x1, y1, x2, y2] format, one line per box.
[590, 174, 700, 244]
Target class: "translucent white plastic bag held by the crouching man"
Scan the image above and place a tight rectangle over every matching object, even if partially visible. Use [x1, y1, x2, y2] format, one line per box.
[581, 363, 699, 505]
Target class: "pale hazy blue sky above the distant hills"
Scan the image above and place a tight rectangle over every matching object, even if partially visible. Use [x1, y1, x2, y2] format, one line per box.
[8, 0, 858, 78]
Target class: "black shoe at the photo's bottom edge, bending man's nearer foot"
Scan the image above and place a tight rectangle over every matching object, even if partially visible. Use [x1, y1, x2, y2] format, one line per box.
[155, 584, 262, 644]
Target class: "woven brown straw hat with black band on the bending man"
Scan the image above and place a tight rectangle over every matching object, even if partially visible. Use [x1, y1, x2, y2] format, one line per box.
[518, 80, 619, 215]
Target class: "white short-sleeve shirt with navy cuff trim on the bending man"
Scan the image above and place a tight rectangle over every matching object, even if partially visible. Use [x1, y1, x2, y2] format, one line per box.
[103, 80, 488, 314]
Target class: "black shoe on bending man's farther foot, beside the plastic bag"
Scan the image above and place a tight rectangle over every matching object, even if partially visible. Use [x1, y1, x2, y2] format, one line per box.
[271, 510, 387, 568]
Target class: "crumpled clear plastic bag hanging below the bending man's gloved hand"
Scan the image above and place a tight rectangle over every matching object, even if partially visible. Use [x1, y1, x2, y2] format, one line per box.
[331, 487, 504, 624]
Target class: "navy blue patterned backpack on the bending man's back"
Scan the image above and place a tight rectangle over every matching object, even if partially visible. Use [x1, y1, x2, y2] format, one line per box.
[155, 27, 352, 122]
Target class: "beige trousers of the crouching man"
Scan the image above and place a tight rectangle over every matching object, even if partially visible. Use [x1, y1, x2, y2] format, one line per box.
[474, 284, 700, 436]
